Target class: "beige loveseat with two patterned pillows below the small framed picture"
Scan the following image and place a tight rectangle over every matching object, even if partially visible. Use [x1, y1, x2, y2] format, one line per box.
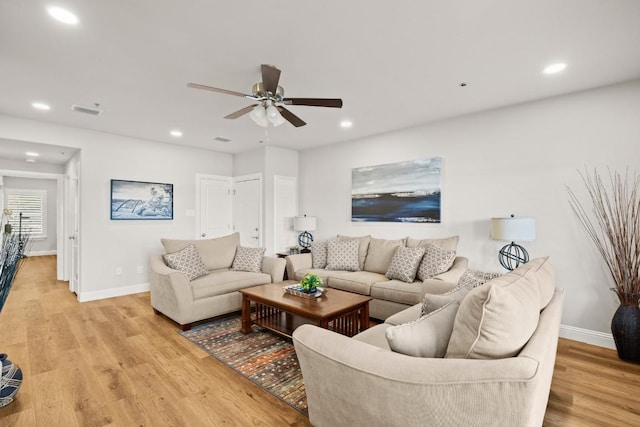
[149, 233, 285, 330]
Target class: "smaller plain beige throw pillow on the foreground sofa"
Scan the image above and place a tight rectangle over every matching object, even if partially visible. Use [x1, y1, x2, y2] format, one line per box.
[385, 301, 460, 357]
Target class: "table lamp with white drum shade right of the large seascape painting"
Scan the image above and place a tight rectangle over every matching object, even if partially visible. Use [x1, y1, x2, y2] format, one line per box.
[491, 215, 536, 271]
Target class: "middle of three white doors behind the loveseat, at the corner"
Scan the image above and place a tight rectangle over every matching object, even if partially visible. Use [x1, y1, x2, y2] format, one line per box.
[233, 174, 262, 248]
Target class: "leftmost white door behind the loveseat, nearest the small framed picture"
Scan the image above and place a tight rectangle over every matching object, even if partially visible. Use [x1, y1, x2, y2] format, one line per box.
[196, 175, 232, 239]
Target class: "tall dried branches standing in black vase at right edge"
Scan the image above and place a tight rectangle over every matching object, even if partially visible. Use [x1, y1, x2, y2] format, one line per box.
[569, 170, 640, 363]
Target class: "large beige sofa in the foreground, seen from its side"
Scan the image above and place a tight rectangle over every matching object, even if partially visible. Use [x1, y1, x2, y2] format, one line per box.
[293, 258, 564, 427]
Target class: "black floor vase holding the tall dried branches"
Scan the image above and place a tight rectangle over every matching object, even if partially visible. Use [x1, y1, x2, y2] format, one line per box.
[611, 305, 640, 364]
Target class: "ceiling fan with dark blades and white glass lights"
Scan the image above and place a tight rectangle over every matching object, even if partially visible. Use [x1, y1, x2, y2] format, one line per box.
[187, 64, 342, 127]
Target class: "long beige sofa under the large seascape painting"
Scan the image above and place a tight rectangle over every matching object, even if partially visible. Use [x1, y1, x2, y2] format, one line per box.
[286, 235, 468, 320]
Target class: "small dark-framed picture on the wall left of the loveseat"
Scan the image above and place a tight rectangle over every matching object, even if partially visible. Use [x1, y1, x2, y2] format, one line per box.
[111, 179, 173, 220]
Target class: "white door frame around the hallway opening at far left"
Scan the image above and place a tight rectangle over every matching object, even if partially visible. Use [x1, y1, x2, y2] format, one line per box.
[0, 169, 68, 280]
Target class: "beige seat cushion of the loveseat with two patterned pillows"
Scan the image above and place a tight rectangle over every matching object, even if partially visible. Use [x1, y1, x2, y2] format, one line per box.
[189, 269, 271, 299]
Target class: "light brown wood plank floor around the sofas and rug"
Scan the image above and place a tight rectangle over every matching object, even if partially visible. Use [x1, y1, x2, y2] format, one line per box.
[0, 256, 640, 427]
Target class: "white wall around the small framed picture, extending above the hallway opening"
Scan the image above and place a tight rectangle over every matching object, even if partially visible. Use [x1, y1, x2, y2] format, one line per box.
[0, 115, 232, 300]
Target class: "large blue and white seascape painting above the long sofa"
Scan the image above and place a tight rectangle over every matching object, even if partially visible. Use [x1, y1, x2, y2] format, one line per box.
[351, 157, 442, 223]
